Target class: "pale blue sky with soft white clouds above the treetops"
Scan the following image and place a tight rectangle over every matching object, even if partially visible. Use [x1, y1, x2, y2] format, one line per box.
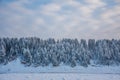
[0, 0, 120, 39]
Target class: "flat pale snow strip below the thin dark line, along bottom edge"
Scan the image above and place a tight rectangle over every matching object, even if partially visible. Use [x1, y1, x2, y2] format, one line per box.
[0, 73, 120, 80]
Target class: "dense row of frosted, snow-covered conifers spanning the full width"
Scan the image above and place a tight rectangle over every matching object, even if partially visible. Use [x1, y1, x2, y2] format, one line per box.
[0, 37, 120, 67]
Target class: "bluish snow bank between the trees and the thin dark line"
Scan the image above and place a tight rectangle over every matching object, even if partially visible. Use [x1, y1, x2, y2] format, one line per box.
[0, 59, 120, 74]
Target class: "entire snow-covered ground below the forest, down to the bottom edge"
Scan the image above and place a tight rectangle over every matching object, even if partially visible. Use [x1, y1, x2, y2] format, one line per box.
[0, 59, 120, 80]
